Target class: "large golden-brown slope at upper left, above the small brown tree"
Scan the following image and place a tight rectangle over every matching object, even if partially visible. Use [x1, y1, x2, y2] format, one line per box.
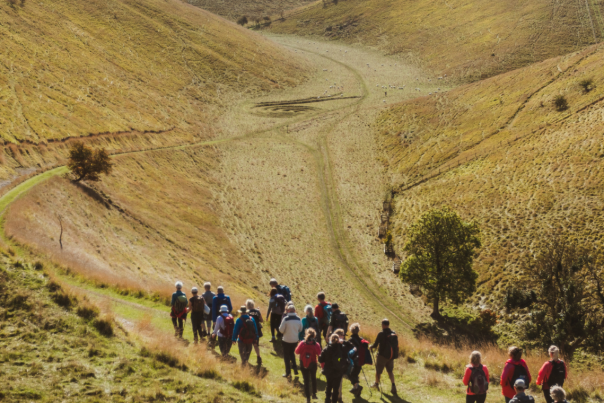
[0, 0, 302, 143]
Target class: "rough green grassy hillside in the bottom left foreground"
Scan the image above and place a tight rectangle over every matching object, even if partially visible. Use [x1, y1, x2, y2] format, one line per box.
[0, 252, 260, 403]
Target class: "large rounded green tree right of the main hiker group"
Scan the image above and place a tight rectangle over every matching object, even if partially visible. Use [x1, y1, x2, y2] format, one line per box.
[400, 207, 481, 318]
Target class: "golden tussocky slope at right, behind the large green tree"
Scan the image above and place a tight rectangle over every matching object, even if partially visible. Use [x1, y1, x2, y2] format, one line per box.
[376, 47, 604, 310]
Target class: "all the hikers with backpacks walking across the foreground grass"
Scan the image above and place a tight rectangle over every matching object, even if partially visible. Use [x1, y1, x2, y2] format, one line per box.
[170, 279, 568, 403]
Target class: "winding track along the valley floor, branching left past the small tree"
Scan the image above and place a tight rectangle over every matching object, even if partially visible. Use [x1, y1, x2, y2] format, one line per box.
[0, 40, 412, 330]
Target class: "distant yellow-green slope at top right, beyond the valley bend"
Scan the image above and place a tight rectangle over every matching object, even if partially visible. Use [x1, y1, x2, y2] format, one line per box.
[271, 0, 604, 81]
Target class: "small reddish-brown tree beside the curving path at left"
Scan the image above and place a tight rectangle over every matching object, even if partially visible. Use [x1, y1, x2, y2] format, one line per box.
[67, 142, 113, 182]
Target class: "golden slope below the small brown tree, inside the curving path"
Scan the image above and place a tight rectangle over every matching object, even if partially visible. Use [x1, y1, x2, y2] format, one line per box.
[6, 147, 253, 302]
